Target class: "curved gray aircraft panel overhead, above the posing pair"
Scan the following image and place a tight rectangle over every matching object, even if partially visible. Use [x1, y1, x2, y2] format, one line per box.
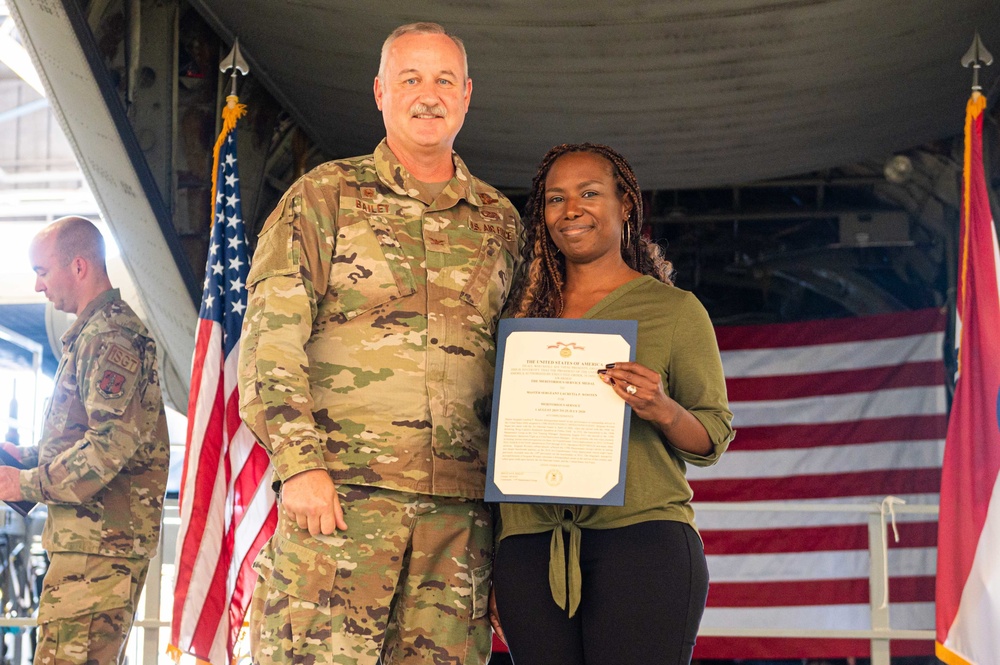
[194, 0, 1000, 189]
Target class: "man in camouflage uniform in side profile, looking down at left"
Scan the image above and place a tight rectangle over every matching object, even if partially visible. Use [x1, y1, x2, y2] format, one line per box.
[0, 217, 170, 665]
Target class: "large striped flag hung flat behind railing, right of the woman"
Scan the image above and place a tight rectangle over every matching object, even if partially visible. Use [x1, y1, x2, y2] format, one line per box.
[688, 309, 947, 658]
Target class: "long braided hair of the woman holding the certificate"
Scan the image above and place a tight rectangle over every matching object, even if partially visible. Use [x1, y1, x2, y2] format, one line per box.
[510, 143, 674, 318]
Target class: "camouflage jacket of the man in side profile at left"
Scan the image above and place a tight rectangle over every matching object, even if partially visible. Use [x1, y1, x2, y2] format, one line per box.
[20, 289, 170, 558]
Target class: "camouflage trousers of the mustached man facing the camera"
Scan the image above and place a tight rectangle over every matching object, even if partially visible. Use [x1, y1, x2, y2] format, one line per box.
[250, 485, 493, 665]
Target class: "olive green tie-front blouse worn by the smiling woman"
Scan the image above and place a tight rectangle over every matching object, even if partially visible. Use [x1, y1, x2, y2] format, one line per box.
[498, 276, 734, 616]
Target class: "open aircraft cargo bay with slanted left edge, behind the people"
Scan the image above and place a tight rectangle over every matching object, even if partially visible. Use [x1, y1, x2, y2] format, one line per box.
[0, 0, 1000, 402]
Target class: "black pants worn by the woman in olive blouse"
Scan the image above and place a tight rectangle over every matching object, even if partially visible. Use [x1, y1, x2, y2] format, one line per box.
[493, 520, 708, 665]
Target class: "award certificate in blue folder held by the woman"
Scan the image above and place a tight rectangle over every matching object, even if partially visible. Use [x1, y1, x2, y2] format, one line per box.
[486, 319, 638, 506]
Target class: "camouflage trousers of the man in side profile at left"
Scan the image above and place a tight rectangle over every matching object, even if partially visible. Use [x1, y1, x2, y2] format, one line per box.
[34, 552, 149, 665]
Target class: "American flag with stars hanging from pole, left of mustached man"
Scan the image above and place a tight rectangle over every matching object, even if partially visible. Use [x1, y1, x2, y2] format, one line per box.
[170, 98, 277, 665]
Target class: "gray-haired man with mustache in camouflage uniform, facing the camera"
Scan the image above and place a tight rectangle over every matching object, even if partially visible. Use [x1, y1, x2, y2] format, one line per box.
[240, 23, 520, 665]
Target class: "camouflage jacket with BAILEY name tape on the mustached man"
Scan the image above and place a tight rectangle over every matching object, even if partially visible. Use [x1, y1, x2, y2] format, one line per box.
[239, 141, 520, 498]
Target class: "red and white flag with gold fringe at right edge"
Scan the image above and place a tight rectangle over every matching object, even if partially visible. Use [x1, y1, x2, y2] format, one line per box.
[937, 92, 1000, 665]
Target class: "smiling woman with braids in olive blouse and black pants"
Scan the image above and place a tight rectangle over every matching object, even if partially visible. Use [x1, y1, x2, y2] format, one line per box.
[491, 144, 733, 665]
